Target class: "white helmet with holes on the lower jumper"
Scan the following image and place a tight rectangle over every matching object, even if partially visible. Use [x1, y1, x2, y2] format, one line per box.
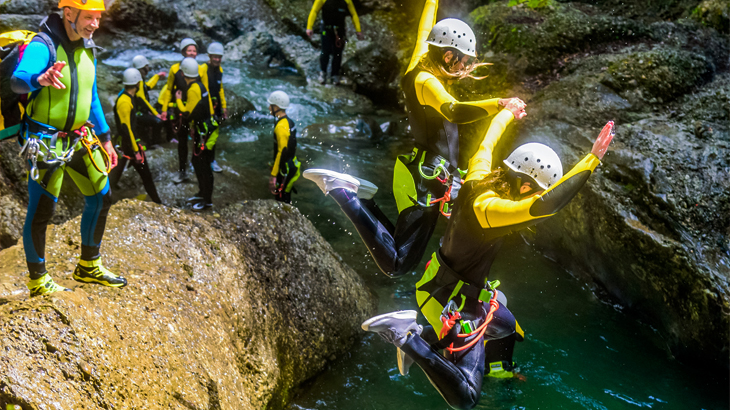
[504, 142, 563, 189]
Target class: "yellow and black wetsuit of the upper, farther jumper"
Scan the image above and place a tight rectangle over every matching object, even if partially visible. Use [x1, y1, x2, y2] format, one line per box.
[330, 0, 506, 276]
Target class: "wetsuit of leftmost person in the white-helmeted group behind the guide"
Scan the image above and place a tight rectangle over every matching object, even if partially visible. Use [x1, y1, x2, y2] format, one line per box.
[109, 92, 162, 204]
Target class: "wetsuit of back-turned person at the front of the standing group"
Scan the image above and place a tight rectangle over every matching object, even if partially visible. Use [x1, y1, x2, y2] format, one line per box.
[176, 79, 218, 204]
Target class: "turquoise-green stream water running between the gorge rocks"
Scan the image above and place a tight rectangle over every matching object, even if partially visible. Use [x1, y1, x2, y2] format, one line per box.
[101, 54, 730, 410]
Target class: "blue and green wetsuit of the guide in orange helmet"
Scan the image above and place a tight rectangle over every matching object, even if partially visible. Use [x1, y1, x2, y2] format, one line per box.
[11, 14, 111, 279]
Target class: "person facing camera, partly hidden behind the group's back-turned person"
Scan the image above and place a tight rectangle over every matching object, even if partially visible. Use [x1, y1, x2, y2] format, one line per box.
[158, 38, 198, 184]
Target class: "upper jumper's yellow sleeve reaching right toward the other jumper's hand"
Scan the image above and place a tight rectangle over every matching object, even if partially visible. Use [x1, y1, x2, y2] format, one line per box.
[415, 71, 499, 124]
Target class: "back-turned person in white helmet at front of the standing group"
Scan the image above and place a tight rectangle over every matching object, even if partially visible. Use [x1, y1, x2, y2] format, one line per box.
[175, 57, 218, 212]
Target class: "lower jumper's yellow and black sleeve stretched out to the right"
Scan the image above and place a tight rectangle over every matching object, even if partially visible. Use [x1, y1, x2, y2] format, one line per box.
[473, 154, 601, 228]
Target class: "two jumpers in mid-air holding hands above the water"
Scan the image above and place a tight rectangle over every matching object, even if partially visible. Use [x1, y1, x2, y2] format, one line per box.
[303, 0, 613, 409]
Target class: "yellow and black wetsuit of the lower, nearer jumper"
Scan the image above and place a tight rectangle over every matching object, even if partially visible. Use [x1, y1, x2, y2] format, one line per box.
[401, 110, 599, 408]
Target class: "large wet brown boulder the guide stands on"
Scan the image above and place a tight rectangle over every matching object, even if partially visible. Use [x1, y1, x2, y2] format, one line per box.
[0, 200, 375, 409]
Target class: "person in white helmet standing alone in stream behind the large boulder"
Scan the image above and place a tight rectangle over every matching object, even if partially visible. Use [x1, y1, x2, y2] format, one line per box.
[267, 91, 302, 204]
